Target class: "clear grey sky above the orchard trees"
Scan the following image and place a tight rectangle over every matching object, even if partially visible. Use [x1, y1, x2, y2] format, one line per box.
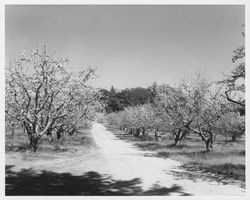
[5, 5, 245, 89]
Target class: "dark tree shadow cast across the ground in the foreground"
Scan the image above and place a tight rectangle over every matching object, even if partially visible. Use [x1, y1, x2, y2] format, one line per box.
[5, 165, 190, 196]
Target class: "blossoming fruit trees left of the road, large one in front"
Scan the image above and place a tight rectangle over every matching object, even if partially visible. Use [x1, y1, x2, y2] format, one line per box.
[5, 46, 103, 151]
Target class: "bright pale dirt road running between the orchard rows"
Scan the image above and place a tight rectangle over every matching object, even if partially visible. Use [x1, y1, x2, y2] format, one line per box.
[92, 123, 245, 195]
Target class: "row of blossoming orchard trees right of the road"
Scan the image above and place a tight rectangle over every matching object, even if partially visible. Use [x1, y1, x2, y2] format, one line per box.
[108, 33, 245, 151]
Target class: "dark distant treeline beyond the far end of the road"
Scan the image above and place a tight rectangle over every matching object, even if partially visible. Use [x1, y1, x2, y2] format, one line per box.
[101, 86, 152, 113]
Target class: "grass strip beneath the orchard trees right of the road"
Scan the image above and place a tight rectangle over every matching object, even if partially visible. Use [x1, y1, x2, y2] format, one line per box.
[108, 126, 245, 187]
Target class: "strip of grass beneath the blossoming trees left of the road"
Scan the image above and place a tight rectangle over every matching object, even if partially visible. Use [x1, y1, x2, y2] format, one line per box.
[5, 125, 95, 160]
